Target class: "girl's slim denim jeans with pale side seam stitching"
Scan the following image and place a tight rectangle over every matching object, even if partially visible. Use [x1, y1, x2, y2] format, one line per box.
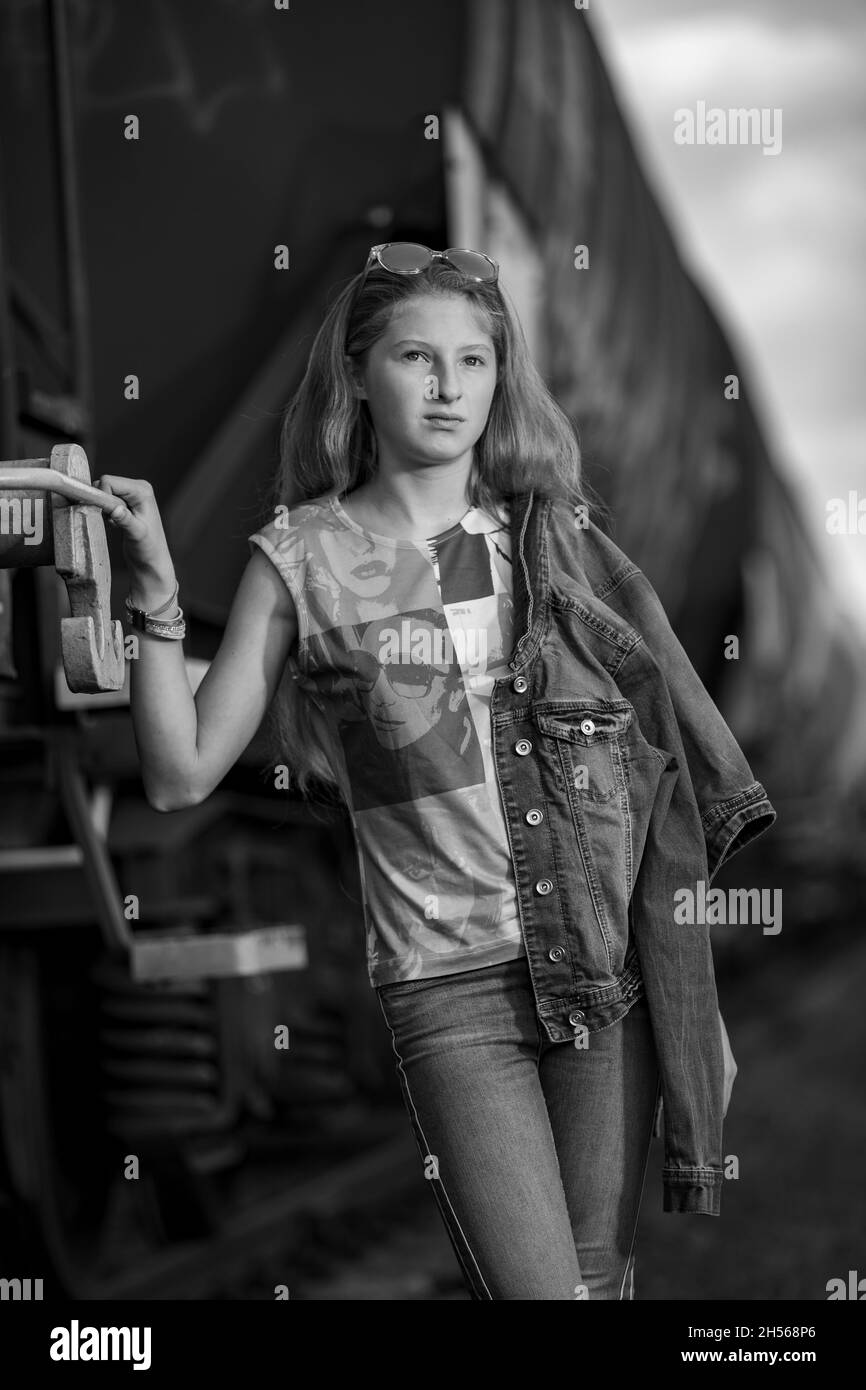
[377, 956, 659, 1300]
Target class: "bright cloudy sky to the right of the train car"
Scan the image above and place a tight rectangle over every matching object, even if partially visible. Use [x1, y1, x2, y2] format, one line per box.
[588, 0, 866, 614]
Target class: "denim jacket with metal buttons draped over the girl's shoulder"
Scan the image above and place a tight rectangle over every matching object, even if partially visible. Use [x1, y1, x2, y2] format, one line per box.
[491, 492, 776, 1215]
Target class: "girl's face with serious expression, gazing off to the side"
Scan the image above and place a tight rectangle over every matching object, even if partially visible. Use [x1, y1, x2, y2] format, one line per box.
[348, 295, 496, 467]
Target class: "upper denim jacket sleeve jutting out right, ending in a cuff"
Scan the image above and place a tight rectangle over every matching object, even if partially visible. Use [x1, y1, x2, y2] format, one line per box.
[603, 562, 776, 881]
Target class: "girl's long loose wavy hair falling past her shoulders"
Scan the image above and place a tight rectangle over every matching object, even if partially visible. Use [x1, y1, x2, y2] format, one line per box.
[270, 261, 594, 799]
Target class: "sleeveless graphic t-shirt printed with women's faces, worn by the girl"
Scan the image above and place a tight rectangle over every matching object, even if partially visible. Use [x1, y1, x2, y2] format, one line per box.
[249, 493, 524, 986]
